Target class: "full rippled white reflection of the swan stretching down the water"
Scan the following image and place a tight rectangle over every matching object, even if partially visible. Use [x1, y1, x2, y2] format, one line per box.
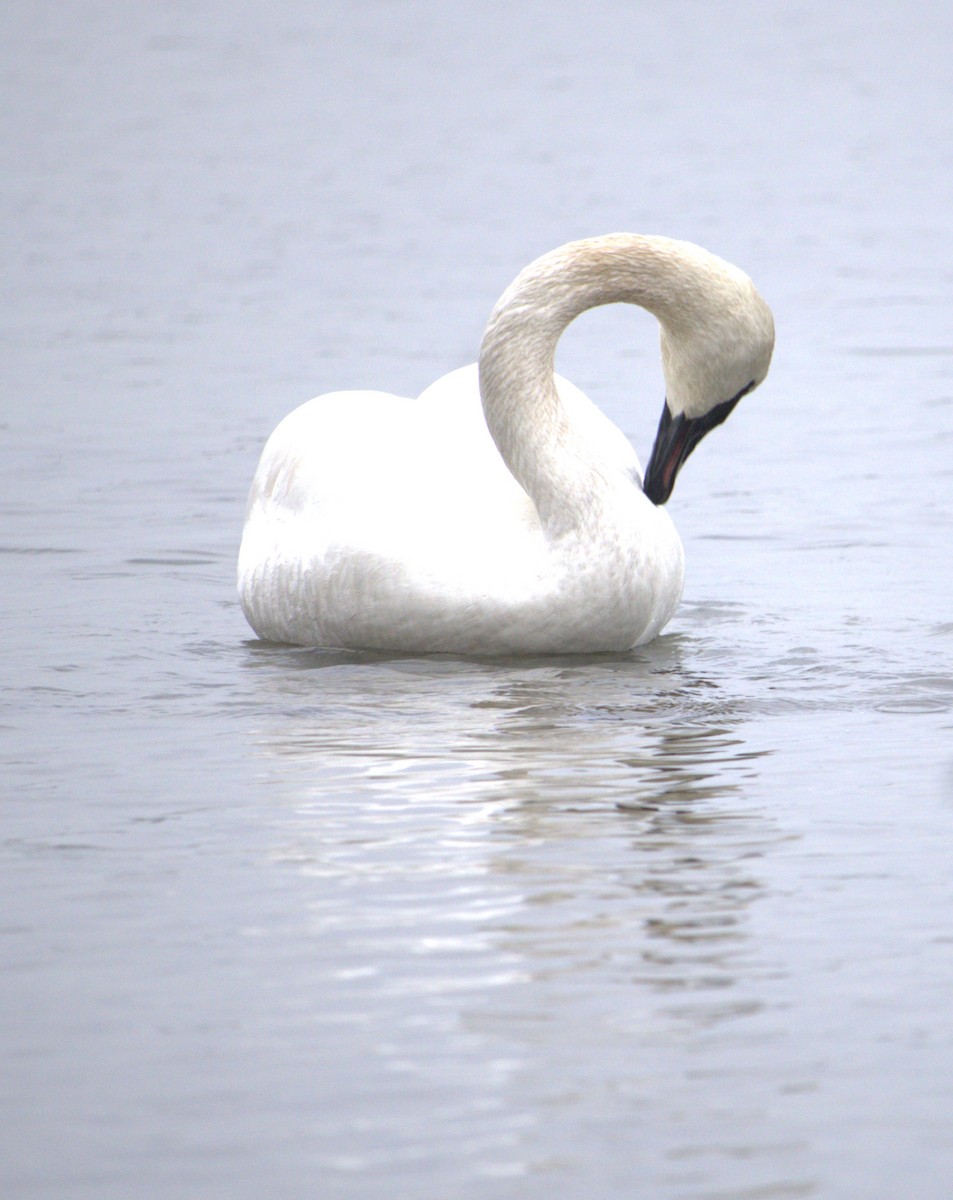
[235, 638, 778, 1176]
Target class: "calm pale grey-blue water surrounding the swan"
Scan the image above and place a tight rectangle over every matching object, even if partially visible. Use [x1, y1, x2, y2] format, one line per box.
[0, 0, 953, 1200]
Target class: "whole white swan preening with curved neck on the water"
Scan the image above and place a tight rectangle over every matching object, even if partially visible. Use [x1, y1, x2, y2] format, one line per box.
[238, 233, 774, 655]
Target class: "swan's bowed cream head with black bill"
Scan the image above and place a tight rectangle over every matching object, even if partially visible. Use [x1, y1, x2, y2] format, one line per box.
[643, 260, 774, 504]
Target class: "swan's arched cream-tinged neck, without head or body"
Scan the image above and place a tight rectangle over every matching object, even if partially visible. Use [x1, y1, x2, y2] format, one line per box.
[480, 234, 685, 532]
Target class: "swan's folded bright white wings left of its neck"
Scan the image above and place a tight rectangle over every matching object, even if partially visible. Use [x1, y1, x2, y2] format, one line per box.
[244, 366, 539, 574]
